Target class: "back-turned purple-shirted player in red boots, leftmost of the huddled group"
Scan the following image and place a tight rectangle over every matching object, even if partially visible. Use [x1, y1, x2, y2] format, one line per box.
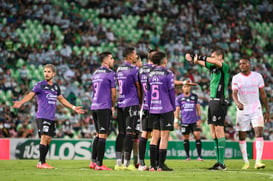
[89, 52, 116, 170]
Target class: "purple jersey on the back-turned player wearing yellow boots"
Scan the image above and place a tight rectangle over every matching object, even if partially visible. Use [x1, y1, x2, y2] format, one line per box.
[116, 62, 139, 108]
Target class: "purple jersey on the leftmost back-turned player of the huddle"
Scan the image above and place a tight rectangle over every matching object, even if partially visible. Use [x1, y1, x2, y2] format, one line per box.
[91, 66, 116, 110]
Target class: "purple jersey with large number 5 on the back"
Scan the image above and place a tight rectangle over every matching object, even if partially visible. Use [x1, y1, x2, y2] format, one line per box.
[147, 66, 175, 114]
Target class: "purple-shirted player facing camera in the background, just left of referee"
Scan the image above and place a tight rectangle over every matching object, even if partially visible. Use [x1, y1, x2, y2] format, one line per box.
[174, 80, 203, 161]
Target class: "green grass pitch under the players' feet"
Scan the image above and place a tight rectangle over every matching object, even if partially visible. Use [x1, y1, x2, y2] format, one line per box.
[0, 160, 273, 181]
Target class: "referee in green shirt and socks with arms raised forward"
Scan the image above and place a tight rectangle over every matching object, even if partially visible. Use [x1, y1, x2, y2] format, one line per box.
[186, 49, 230, 170]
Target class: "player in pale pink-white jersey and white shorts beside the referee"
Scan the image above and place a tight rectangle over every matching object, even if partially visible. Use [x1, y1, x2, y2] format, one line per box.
[232, 58, 269, 169]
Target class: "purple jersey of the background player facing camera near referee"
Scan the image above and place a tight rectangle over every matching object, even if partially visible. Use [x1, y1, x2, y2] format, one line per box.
[175, 93, 199, 124]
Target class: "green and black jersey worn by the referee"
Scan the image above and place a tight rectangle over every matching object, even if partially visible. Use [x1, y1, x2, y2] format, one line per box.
[206, 62, 230, 99]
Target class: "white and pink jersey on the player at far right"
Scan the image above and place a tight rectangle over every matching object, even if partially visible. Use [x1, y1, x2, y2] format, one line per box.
[232, 71, 264, 114]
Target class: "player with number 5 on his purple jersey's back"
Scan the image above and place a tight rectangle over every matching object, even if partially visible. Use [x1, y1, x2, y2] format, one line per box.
[147, 52, 175, 171]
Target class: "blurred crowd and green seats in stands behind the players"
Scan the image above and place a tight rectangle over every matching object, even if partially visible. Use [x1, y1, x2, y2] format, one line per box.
[0, 0, 273, 140]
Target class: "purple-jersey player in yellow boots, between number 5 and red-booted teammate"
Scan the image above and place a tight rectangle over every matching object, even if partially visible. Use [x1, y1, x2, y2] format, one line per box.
[115, 47, 142, 170]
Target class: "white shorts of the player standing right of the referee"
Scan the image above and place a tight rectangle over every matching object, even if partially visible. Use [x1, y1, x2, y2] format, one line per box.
[236, 109, 264, 131]
